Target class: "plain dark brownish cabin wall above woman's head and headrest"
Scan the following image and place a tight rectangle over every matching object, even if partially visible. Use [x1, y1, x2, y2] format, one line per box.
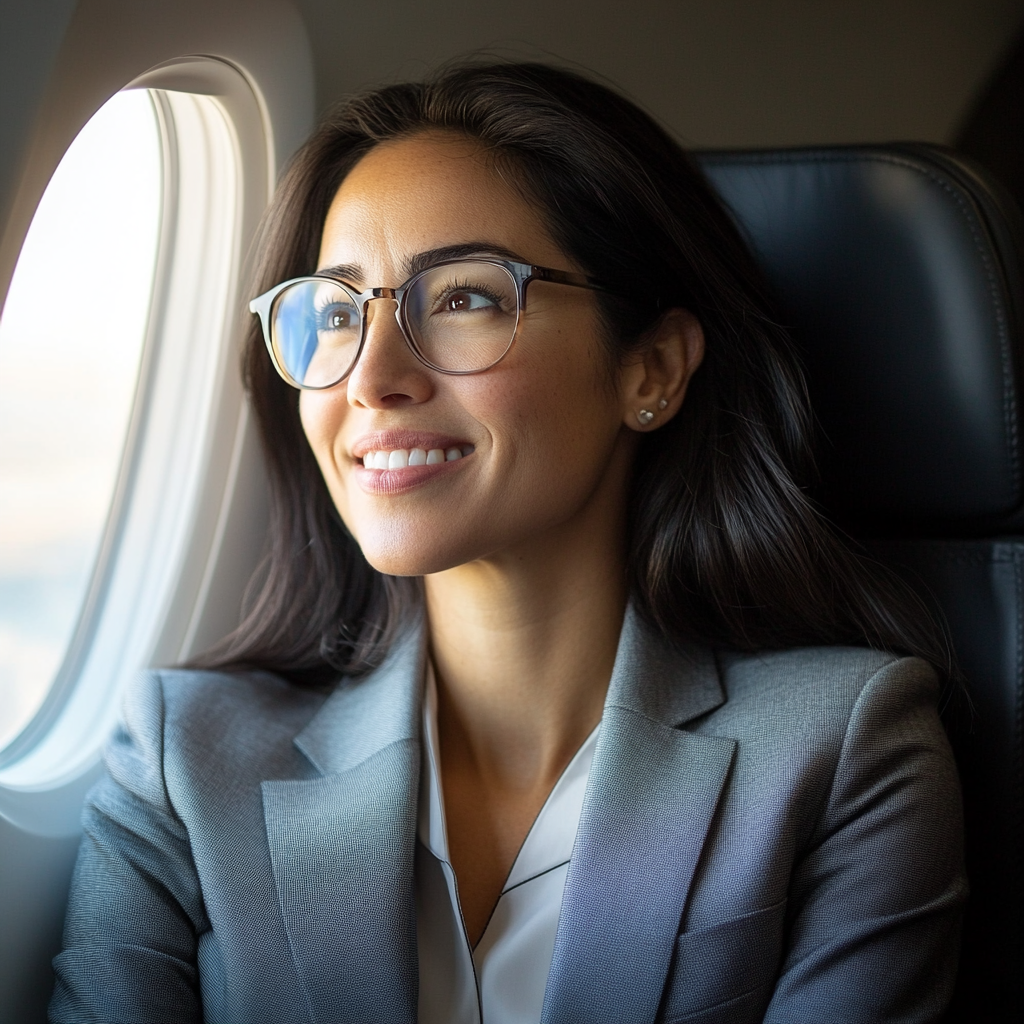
[298, 0, 1024, 147]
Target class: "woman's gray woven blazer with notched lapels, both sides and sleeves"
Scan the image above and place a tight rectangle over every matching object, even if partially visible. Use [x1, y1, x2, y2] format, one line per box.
[51, 611, 966, 1024]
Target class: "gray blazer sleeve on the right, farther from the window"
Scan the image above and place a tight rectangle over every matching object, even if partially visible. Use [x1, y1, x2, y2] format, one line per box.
[765, 658, 967, 1024]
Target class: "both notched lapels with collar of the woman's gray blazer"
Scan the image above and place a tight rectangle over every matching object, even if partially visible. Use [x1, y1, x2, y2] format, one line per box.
[263, 606, 735, 1024]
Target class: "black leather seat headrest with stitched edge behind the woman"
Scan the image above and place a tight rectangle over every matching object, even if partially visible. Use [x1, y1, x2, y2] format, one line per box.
[697, 144, 1024, 532]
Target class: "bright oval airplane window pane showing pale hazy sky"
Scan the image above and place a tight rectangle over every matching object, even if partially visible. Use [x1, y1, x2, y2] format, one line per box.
[0, 89, 162, 748]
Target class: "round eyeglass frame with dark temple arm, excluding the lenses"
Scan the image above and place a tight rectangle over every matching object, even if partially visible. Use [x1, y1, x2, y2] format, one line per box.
[249, 256, 615, 391]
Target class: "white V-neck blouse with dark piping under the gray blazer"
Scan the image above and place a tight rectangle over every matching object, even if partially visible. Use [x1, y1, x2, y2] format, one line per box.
[416, 668, 600, 1024]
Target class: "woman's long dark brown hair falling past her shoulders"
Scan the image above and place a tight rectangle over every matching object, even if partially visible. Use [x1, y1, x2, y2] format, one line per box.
[194, 63, 948, 685]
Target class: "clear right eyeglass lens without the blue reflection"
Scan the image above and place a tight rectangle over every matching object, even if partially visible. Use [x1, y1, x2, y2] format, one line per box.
[406, 262, 518, 372]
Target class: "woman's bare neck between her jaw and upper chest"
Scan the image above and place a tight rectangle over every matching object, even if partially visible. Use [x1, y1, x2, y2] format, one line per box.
[425, 495, 627, 792]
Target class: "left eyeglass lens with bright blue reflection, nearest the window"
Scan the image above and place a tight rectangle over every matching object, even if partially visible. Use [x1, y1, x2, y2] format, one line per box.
[271, 281, 360, 387]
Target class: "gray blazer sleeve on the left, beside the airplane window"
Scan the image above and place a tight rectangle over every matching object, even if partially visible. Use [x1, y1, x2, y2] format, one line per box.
[50, 673, 208, 1024]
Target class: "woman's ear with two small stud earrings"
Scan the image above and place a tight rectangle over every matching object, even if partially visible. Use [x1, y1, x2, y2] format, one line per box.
[621, 309, 705, 432]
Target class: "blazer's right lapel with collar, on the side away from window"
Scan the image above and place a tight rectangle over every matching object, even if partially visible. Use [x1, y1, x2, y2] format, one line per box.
[541, 607, 735, 1024]
